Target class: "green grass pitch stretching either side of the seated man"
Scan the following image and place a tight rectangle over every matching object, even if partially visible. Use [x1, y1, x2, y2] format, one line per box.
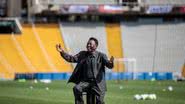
[0, 81, 185, 104]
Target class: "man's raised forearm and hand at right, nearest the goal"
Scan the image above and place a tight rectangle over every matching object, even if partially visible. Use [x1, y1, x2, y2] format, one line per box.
[103, 54, 114, 69]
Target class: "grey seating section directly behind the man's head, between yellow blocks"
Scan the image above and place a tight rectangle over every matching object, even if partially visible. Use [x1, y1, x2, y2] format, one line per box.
[61, 22, 108, 54]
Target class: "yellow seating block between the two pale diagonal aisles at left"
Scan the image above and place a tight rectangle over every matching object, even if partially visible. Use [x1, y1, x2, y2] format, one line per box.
[16, 24, 51, 72]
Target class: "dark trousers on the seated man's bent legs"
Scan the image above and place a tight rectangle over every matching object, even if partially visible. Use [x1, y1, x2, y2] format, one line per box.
[73, 82, 105, 104]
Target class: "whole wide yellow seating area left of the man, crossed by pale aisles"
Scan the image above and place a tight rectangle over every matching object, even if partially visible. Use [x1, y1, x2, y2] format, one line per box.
[0, 24, 72, 78]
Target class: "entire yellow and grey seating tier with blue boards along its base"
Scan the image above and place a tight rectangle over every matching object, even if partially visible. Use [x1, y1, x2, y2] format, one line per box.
[0, 20, 185, 80]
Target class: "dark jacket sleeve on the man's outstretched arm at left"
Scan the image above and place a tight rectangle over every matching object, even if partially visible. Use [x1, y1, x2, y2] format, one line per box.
[60, 52, 81, 63]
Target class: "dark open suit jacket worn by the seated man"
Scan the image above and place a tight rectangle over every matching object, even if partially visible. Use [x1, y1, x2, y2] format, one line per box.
[60, 51, 114, 92]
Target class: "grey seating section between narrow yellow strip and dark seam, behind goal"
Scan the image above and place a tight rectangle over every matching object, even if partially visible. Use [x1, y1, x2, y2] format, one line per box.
[121, 22, 155, 72]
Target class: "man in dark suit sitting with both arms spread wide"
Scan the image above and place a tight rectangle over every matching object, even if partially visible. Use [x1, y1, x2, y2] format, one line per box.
[56, 37, 114, 104]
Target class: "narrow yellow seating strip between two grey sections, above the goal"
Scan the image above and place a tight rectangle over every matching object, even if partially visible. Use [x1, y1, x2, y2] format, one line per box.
[105, 23, 125, 72]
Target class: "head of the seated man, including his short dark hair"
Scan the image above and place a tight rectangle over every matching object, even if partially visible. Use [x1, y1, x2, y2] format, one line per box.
[86, 37, 98, 52]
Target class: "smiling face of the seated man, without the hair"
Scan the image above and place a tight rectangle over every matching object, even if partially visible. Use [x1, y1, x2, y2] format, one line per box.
[86, 40, 97, 52]
